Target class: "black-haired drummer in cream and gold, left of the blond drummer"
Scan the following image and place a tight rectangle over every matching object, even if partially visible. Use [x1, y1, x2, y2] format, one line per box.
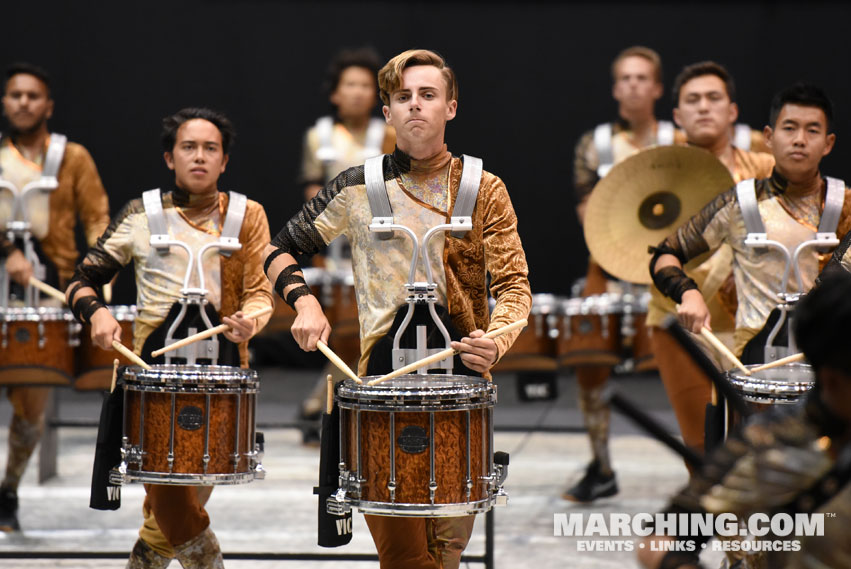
[67, 108, 272, 569]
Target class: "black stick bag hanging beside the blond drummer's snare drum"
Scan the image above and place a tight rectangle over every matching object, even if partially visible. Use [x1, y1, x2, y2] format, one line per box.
[313, 386, 352, 547]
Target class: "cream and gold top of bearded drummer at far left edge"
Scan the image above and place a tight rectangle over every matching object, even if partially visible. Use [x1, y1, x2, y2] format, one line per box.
[0, 137, 109, 286]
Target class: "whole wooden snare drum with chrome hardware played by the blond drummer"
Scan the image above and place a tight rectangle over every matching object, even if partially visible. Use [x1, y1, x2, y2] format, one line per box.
[328, 375, 507, 517]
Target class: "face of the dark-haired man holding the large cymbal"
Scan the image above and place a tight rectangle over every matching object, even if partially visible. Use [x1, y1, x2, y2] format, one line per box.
[674, 75, 739, 147]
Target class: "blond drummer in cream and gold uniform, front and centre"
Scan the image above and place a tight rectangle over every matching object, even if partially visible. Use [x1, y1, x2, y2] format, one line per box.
[266, 50, 531, 568]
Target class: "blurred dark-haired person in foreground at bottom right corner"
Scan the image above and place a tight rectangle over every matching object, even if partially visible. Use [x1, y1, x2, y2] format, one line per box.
[637, 270, 851, 569]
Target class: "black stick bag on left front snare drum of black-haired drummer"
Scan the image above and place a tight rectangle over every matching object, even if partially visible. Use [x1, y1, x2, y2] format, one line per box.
[89, 381, 124, 510]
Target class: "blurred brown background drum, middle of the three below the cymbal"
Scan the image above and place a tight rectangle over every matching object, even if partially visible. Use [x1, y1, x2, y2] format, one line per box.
[557, 293, 623, 366]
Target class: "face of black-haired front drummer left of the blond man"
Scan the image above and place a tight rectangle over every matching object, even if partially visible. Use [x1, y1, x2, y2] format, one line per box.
[164, 119, 228, 194]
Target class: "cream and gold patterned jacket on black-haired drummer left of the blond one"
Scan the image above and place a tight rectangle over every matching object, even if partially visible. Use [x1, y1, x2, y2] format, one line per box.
[74, 192, 272, 367]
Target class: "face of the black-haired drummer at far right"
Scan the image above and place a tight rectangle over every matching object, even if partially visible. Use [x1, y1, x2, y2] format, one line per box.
[765, 103, 836, 182]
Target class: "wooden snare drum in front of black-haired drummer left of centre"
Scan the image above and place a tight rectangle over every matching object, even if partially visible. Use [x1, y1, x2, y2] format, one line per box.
[110, 364, 265, 486]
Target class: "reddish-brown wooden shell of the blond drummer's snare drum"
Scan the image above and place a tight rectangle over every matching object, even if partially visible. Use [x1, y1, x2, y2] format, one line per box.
[340, 409, 491, 505]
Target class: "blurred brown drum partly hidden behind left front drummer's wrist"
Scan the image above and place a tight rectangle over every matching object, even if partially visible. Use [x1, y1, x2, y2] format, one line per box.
[74, 306, 136, 390]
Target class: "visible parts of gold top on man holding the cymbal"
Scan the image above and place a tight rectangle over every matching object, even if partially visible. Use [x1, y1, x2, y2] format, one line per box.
[647, 147, 774, 332]
